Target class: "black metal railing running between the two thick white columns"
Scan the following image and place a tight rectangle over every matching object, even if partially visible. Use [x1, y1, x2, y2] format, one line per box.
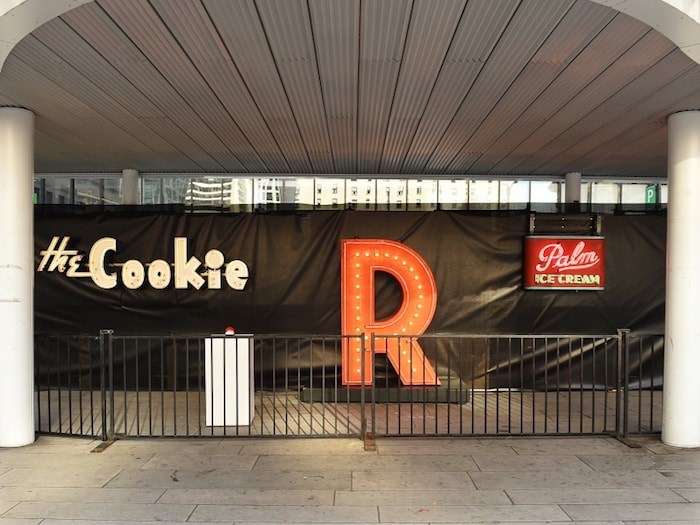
[35, 330, 663, 439]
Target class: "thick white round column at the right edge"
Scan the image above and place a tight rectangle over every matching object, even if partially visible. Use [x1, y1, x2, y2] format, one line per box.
[661, 111, 700, 447]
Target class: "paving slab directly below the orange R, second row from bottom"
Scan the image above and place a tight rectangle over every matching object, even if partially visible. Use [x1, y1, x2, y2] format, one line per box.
[335, 487, 508, 506]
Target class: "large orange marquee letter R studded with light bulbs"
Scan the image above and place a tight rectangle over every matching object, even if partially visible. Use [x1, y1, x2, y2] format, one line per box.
[340, 239, 440, 385]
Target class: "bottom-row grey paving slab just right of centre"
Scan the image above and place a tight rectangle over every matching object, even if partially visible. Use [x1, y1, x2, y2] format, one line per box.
[379, 505, 568, 523]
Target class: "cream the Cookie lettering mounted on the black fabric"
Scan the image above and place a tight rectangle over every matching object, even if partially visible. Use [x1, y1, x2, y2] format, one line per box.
[37, 236, 249, 290]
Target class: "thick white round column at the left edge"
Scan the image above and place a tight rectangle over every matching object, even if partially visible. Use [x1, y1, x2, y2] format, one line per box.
[0, 108, 34, 447]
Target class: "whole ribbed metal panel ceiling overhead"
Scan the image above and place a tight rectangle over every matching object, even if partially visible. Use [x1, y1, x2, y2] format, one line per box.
[0, 0, 700, 176]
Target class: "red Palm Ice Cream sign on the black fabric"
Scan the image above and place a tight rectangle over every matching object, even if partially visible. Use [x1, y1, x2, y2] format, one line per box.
[523, 236, 605, 290]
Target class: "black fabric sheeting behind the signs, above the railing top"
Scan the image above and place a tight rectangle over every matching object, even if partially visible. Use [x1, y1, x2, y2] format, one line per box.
[35, 211, 666, 334]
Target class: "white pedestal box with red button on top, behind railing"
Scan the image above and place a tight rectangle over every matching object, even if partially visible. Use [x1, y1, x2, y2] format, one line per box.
[204, 335, 255, 426]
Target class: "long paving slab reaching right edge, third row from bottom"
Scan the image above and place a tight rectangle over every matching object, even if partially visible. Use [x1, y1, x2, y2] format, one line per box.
[469, 470, 696, 489]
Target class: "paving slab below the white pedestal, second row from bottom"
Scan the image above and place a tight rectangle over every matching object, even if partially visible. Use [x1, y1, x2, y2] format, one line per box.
[158, 489, 334, 505]
